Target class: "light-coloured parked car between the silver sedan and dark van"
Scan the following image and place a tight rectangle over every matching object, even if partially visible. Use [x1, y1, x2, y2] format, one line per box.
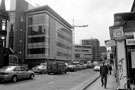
[32, 64, 47, 74]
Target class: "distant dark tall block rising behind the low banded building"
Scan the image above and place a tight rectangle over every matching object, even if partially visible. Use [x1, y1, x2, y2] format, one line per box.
[82, 39, 100, 61]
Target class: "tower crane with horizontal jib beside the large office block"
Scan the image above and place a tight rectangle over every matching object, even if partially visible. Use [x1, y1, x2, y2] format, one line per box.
[72, 19, 88, 60]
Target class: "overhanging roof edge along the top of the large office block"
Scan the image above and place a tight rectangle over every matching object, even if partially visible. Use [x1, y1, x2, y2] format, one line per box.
[24, 5, 73, 28]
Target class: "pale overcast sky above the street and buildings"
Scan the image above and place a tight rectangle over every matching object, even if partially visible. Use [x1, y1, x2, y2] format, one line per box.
[0, 0, 133, 46]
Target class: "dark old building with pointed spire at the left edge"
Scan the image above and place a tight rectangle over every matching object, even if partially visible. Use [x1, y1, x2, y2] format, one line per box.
[0, 0, 9, 68]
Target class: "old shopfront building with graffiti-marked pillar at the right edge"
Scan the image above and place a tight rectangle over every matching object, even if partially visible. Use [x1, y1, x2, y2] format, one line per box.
[109, 1, 135, 90]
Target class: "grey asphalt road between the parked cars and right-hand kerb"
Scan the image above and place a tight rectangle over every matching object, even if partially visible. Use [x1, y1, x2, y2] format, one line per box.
[0, 69, 99, 90]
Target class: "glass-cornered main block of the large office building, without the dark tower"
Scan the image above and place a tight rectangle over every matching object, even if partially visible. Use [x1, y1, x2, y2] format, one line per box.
[25, 6, 72, 66]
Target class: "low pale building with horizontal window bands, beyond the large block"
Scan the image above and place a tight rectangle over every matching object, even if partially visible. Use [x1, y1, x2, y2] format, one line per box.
[75, 45, 93, 63]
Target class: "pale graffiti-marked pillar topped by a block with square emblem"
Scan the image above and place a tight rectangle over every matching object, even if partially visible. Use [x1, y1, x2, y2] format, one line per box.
[110, 25, 127, 88]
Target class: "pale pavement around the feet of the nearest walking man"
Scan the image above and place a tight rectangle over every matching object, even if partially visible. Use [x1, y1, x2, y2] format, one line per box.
[85, 74, 118, 90]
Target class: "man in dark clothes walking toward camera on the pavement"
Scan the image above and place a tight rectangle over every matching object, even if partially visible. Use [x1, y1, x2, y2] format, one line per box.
[100, 62, 108, 88]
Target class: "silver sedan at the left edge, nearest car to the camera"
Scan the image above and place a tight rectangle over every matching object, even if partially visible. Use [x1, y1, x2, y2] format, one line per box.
[0, 66, 35, 82]
